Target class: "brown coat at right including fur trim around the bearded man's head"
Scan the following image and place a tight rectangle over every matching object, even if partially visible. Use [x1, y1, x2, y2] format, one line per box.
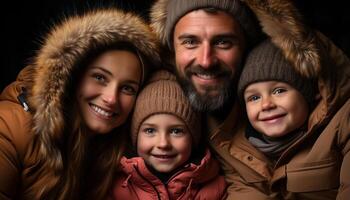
[152, 0, 350, 200]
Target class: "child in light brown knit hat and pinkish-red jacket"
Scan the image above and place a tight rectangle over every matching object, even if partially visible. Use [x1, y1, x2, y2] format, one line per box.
[113, 71, 226, 200]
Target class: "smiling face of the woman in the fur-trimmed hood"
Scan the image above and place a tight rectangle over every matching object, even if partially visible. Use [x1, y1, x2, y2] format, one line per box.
[77, 50, 142, 134]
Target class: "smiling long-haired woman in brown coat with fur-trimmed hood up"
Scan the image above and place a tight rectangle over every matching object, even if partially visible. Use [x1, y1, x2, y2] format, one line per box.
[0, 8, 160, 200]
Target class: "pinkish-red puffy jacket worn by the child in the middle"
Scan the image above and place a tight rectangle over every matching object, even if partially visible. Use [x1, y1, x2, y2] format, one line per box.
[113, 150, 226, 200]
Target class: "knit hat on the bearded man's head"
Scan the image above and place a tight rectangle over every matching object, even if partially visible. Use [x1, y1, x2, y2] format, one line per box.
[165, 0, 258, 47]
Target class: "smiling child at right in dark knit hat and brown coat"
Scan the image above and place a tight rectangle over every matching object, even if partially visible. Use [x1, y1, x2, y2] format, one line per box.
[230, 40, 350, 200]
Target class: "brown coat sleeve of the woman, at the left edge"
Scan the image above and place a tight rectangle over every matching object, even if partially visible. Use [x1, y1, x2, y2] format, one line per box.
[0, 97, 32, 200]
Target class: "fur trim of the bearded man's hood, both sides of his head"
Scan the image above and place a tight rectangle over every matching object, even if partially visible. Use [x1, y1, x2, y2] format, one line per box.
[151, 0, 320, 77]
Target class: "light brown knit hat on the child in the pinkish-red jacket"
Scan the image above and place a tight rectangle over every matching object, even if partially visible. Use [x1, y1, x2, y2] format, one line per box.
[131, 70, 201, 148]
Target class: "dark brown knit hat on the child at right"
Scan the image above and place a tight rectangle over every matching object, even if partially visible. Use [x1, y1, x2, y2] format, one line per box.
[237, 39, 316, 106]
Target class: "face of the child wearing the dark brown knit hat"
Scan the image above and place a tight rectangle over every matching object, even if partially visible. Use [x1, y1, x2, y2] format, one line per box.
[244, 81, 309, 137]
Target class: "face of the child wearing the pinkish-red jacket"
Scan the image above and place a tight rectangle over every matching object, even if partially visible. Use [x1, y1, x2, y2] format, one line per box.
[137, 114, 192, 173]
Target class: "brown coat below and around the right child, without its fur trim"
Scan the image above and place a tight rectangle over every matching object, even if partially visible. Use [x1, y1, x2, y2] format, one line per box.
[210, 31, 350, 200]
